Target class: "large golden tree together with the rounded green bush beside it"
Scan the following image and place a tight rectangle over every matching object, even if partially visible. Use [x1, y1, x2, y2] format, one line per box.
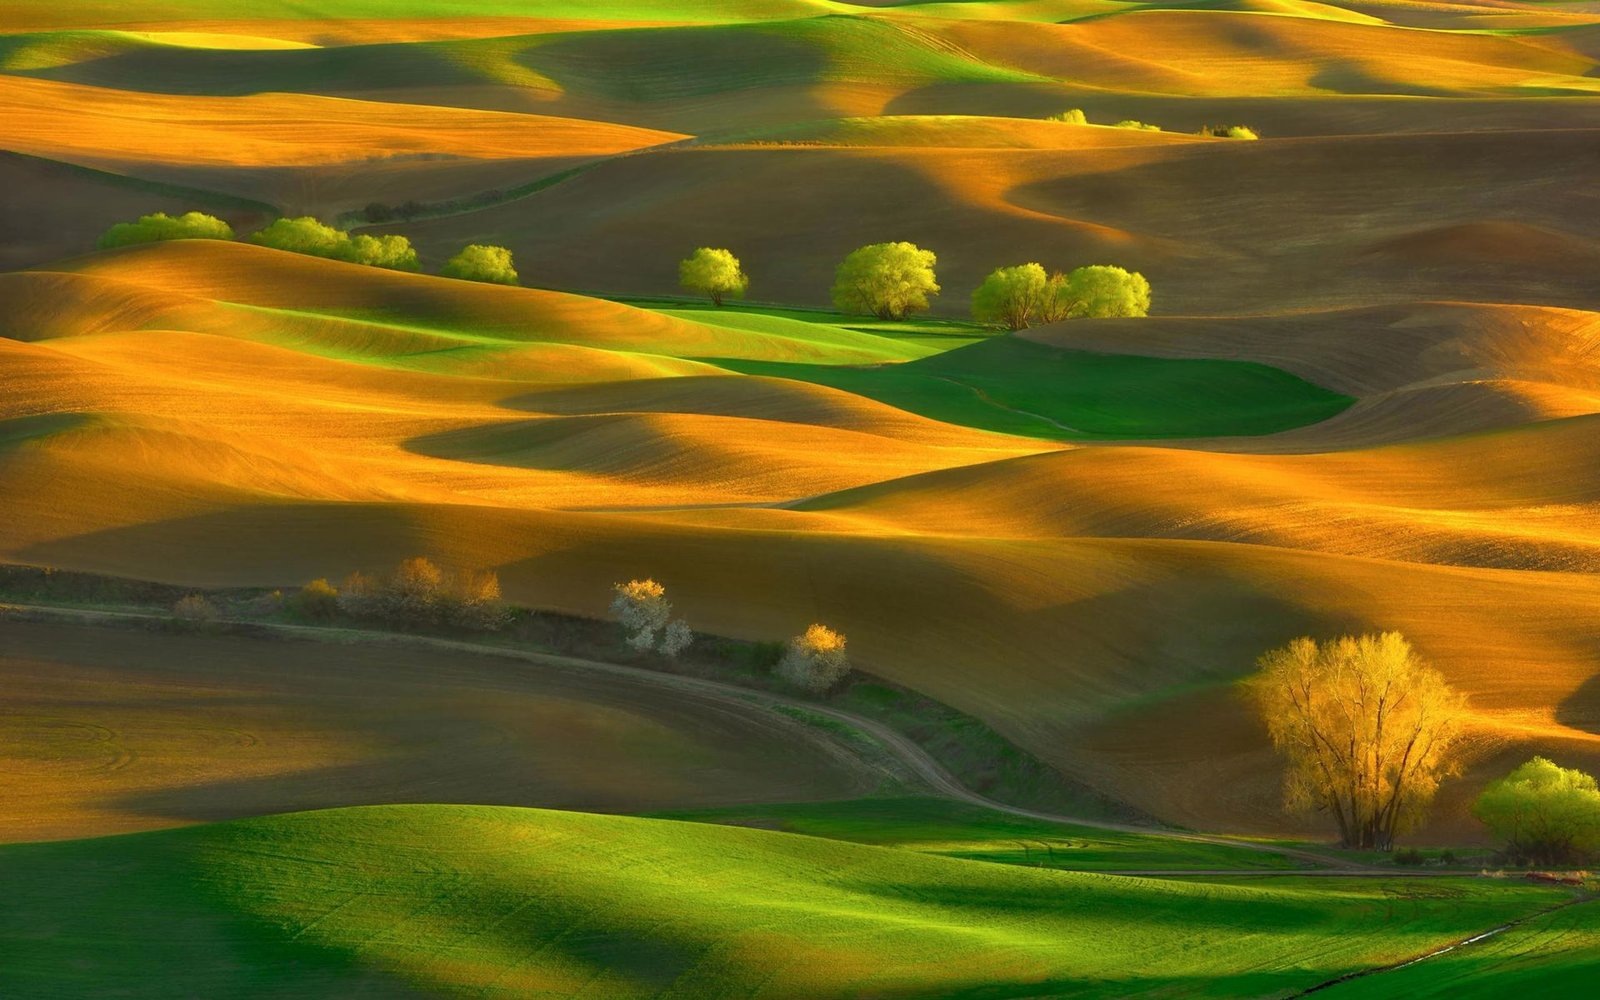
[1250, 632, 1600, 864]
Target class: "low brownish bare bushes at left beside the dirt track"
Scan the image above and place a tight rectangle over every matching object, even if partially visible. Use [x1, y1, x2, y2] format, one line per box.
[294, 557, 507, 632]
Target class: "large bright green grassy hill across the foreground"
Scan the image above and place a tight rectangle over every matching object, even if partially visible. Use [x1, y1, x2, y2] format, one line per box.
[0, 806, 1558, 998]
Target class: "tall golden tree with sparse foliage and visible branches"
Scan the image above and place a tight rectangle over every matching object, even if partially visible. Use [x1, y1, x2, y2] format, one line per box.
[1250, 632, 1464, 850]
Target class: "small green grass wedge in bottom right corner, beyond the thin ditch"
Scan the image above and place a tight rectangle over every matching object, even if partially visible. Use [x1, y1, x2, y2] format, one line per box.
[1325, 899, 1600, 1000]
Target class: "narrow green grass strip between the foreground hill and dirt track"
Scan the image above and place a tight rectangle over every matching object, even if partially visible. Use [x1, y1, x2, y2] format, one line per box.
[662, 797, 1310, 872]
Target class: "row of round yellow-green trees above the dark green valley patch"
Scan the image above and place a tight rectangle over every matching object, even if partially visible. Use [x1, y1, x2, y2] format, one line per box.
[678, 242, 1150, 330]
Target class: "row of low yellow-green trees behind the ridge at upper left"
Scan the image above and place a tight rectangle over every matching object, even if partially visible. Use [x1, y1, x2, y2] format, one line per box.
[99, 211, 518, 285]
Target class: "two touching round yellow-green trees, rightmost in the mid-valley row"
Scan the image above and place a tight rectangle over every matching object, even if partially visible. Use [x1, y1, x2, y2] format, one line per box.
[973, 264, 1150, 330]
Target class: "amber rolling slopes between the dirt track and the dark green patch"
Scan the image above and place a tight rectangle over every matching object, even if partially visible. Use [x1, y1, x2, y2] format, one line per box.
[0, 243, 1600, 830]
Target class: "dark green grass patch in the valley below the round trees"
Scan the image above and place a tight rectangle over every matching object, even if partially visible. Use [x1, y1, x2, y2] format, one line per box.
[720, 338, 1354, 440]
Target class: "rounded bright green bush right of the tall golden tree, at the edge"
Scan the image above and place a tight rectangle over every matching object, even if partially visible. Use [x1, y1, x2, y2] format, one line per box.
[1472, 757, 1600, 866]
